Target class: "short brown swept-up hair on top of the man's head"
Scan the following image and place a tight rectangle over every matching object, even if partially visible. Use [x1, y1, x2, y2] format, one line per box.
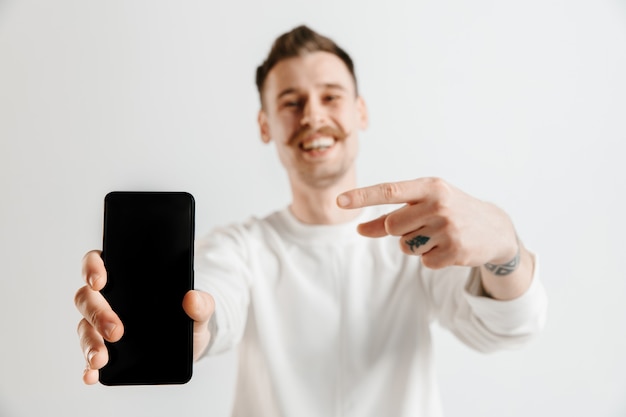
[256, 25, 357, 101]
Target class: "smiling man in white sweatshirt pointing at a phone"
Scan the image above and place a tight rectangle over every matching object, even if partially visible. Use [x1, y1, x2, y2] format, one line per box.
[76, 26, 546, 416]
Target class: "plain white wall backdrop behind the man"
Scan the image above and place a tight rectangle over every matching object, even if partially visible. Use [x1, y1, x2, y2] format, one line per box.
[0, 0, 626, 417]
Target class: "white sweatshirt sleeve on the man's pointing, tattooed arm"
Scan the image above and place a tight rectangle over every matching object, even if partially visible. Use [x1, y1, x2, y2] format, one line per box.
[424, 254, 547, 352]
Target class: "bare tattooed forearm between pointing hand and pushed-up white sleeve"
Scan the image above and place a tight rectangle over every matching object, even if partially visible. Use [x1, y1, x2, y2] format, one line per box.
[480, 242, 535, 301]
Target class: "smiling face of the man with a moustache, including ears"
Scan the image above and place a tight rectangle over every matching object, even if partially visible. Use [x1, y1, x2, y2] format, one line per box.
[259, 52, 367, 188]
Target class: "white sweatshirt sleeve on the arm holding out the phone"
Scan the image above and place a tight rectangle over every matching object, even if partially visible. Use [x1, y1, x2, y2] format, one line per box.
[195, 227, 251, 354]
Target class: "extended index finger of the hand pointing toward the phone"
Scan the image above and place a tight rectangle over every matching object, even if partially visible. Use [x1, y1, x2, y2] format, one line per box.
[337, 179, 426, 209]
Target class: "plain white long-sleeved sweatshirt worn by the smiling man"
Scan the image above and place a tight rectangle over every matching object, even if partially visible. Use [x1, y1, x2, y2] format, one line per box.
[195, 209, 547, 417]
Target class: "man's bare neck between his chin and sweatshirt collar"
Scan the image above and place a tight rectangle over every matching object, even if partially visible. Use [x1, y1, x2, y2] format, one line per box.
[290, 173, 359, 224]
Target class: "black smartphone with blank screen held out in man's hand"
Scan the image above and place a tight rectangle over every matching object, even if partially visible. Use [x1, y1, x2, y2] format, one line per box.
[99, 191, 195, 385]
